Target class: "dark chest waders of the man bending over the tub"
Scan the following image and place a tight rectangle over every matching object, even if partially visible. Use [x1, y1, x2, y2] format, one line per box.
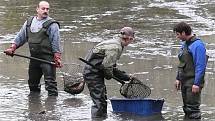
[83, 50, 107, 118]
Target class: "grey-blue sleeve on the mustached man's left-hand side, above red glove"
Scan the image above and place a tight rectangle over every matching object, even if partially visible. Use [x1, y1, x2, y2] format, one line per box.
[14, 21, 27, 47]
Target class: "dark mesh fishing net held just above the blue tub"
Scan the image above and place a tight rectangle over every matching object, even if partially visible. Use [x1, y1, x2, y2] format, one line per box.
[120, 78, 151, 98]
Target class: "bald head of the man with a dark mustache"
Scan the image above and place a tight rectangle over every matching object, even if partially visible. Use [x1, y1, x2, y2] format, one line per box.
[37, 2, 49, 19]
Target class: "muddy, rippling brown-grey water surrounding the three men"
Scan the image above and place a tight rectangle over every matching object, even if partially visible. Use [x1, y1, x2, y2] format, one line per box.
[0, 0, 215, 121]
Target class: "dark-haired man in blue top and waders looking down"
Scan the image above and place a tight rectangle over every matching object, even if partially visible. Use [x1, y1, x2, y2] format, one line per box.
[173, 22, 207, 119]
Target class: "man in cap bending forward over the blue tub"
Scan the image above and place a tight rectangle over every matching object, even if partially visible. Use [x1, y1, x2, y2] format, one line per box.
[83, 27, 134, 118]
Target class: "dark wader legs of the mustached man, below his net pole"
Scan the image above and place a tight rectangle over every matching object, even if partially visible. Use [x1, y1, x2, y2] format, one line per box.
[28, 60, 58, 96]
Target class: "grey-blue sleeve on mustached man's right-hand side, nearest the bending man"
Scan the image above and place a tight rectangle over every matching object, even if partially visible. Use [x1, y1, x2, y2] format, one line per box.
[47, 23, 62, 53]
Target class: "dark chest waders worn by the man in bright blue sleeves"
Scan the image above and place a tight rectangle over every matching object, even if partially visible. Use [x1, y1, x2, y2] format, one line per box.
[178, 39, 204, 119]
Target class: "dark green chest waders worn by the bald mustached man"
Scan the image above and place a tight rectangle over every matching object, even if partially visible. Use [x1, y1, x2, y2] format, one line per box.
[26, 17, 61, 96]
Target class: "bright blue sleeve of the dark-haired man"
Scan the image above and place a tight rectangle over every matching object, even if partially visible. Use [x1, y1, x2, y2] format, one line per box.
[191, 43, 206, 86]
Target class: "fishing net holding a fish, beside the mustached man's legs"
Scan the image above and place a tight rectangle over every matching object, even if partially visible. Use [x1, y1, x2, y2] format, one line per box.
[61, 63, 85, 95]
